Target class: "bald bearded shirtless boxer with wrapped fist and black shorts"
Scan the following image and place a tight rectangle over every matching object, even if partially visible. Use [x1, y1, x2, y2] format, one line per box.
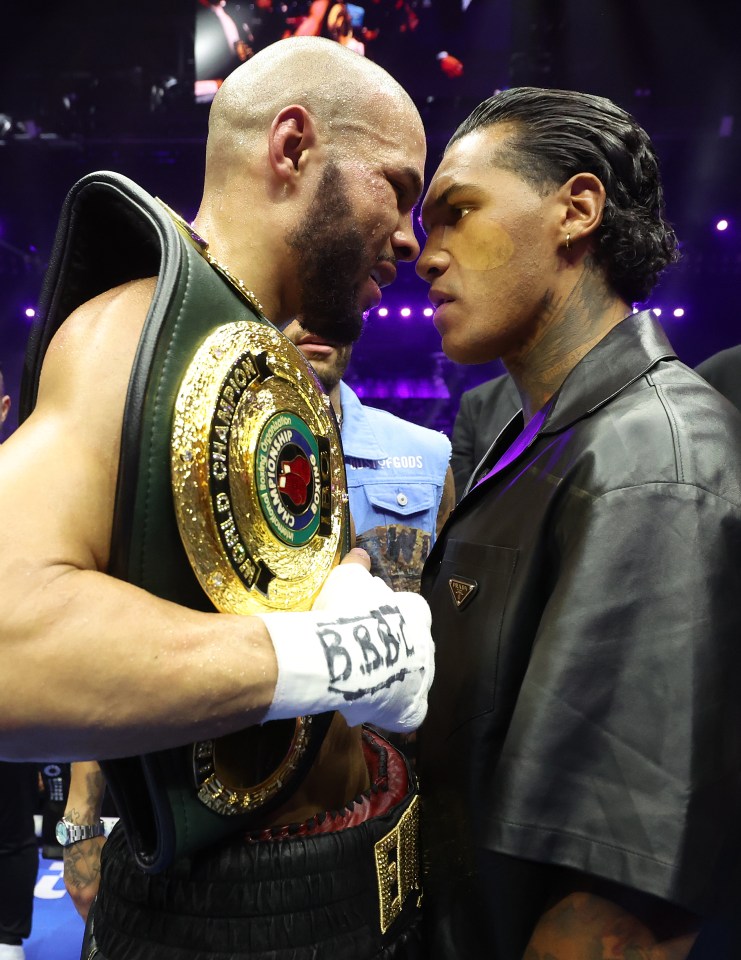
[0, 38, 433, 960]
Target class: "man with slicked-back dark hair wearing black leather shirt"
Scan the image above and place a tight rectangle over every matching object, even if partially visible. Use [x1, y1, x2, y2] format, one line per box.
[417, 87, 741, 960]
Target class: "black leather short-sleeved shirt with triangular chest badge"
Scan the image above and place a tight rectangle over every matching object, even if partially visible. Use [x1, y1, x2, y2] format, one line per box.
[419, 313, 741, 960]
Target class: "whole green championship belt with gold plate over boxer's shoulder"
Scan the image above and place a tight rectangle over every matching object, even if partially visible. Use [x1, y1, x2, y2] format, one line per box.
[21, 171, 349, 872]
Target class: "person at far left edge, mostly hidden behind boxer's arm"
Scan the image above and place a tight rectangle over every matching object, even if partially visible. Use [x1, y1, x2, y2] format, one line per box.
[0, 368, 39, 960]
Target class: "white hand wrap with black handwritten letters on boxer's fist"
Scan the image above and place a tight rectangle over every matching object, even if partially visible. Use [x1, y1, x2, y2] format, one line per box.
[259, 563, 435, 731]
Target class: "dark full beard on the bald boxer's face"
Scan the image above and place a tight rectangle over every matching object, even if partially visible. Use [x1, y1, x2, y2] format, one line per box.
[288, 161, 368, 343]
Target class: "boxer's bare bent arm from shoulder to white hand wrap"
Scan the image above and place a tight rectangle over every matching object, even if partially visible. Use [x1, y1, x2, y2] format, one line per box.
[0, 281, 430, 760]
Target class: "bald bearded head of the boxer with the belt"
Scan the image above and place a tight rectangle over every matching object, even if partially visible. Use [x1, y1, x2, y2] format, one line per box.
[194, 37, 426, 332]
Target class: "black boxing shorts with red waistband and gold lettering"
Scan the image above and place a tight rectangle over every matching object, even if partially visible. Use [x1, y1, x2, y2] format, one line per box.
[82, 728, 422, 960]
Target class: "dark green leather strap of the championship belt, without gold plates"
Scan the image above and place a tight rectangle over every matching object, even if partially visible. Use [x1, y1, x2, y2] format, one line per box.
[21, 171, 338, 872]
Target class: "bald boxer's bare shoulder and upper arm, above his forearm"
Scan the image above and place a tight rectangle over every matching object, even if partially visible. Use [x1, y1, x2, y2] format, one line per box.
[0, 279, 155, 570]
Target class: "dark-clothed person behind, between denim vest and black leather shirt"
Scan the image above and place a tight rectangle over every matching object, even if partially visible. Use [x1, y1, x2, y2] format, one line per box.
[450, 373, 520, 502]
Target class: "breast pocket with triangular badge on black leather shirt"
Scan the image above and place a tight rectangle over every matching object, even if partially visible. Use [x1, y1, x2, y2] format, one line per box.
[428, 540, 518, 733]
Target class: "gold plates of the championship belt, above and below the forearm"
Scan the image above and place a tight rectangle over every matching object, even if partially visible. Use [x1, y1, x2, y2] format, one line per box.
[171, 321, 347, 816]
